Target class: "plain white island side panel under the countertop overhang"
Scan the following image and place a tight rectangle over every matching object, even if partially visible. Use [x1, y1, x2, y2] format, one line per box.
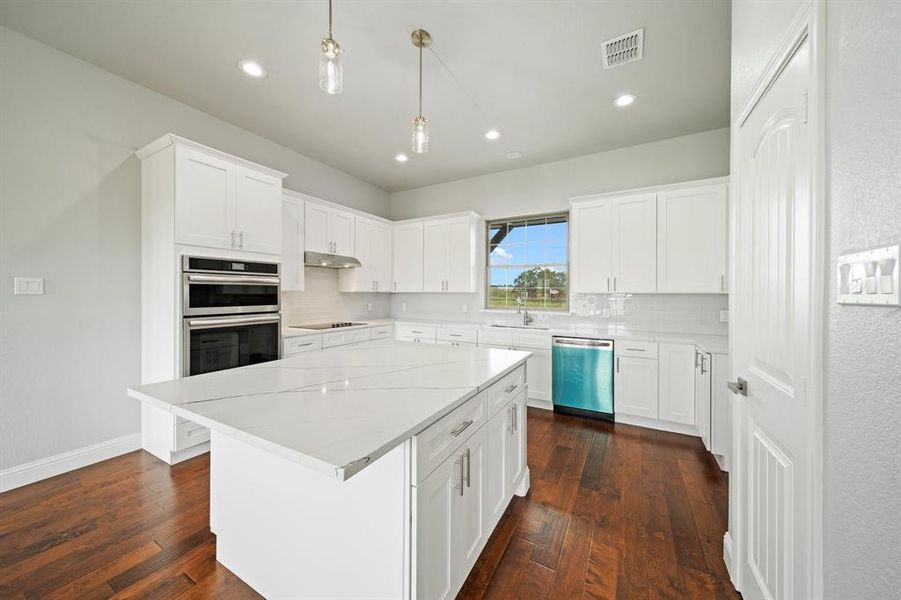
[210, 431, 410, 599]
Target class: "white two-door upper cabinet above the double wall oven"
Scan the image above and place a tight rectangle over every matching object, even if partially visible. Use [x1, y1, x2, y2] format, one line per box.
[137, 134, 285, 254]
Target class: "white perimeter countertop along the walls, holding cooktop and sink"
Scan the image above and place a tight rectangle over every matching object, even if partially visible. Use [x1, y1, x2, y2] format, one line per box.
[282, 319, 729, 354]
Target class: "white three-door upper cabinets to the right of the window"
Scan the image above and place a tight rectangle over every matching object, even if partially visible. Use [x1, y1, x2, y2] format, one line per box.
[570, 180, 727, 294]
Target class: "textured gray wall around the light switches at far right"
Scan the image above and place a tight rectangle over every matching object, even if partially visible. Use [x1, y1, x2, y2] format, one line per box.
[824, 1, 901, 599]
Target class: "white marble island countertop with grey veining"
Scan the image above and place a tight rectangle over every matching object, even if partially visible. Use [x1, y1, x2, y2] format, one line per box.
[128, 342, 530, 481]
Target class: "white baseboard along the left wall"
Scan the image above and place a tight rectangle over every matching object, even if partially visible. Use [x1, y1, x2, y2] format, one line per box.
[0, 433, 141, 492]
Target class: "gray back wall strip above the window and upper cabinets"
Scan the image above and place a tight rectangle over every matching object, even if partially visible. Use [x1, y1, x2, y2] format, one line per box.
[391, 129, 729, 219]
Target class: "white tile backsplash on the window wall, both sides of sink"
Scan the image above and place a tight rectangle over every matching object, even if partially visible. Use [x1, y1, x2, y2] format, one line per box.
[390, 294, 729, 335]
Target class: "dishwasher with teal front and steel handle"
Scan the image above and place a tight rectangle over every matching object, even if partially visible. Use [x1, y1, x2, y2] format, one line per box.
[551, 337, 613, 420]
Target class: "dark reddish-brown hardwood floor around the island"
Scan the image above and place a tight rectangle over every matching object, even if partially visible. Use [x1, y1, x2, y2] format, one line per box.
[0, 409, 738, 600]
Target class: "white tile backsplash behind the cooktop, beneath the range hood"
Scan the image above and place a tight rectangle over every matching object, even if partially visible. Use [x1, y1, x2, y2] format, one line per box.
[282, 267, 391, 325]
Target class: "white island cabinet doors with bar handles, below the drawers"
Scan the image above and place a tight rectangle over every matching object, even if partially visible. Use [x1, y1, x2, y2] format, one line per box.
[413, 382, 526, 600]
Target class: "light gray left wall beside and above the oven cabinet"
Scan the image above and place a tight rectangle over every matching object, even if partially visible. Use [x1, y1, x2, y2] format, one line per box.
[0, 28, 389, 469]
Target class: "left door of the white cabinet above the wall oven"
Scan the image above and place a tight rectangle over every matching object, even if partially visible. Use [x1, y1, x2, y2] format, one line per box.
[175, 147, 238, 248]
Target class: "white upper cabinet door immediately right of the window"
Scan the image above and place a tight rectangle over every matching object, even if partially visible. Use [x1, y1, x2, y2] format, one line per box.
[571, 200, 615, 294]
